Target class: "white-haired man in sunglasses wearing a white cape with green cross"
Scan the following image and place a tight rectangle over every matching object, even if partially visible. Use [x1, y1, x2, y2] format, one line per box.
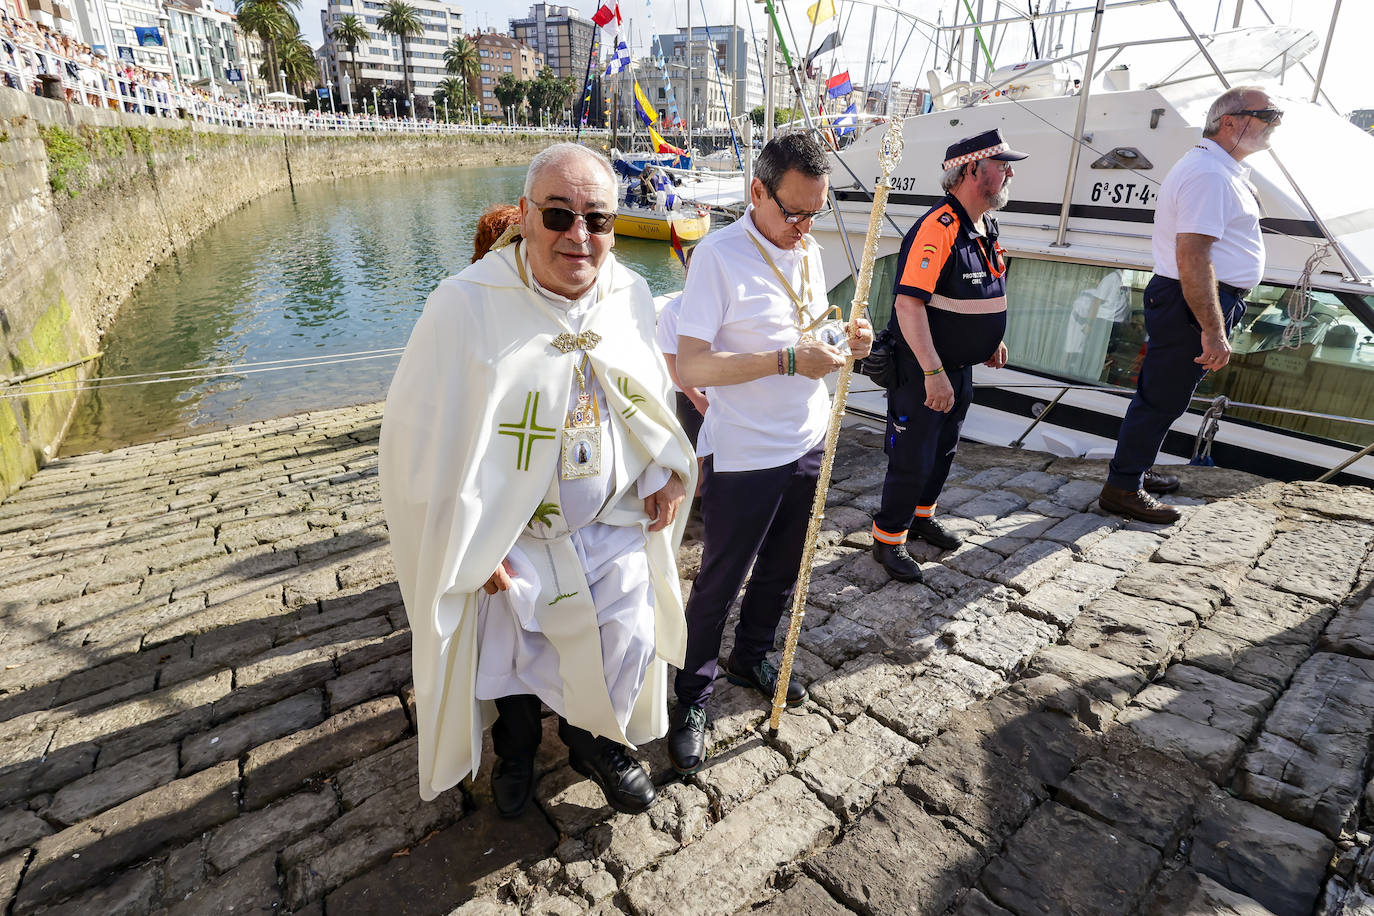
[381, 143, 697, 817]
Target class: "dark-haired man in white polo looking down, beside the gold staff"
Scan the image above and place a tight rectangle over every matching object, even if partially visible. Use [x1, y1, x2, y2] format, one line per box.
[668, 133, 872, 775]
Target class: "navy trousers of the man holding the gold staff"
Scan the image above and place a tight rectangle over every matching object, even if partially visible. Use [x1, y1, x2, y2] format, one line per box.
[673, 446, 822, 706]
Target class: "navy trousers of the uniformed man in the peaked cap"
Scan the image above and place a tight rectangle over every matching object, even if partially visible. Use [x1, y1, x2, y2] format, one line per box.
[872, 365, 973, 534]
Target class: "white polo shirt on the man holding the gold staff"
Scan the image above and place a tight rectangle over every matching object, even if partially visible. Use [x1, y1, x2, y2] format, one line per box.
[677, 206, 830, 471]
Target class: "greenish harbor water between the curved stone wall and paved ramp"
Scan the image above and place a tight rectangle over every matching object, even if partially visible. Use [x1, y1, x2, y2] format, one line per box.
[62, 166, 683, 455]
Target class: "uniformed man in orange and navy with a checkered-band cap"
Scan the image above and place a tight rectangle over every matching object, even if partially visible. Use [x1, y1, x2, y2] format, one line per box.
[872, 130, 1026, 582]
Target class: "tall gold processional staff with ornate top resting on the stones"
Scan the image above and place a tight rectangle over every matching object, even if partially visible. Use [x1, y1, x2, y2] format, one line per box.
[768, 118, 903, 737]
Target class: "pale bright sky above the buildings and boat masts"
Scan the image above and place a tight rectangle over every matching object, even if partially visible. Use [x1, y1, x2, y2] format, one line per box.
[301, 0, 1374, 113]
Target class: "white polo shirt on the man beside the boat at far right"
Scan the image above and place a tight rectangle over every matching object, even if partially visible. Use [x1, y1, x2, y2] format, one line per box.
[1151, 137, 1264, 290]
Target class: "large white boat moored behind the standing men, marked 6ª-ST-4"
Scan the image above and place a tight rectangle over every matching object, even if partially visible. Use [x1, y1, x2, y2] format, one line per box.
[812, 0, 1374, 483]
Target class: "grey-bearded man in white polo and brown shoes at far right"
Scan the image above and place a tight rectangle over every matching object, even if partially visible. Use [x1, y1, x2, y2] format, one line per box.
[1098, 87, 1283, 525]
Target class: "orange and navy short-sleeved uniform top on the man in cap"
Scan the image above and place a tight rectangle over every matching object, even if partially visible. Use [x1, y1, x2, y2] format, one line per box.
[892, 194, 1007, 368]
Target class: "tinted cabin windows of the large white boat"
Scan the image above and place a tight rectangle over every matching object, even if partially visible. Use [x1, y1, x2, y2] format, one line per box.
[830, 255, 1374, 446]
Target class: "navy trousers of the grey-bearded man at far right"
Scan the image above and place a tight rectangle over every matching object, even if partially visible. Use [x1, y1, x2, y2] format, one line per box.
[1107, 276, 1245, 490]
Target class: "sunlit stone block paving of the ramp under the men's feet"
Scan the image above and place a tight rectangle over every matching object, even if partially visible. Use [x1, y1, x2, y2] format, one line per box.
[0, 405, 1374, 916]
